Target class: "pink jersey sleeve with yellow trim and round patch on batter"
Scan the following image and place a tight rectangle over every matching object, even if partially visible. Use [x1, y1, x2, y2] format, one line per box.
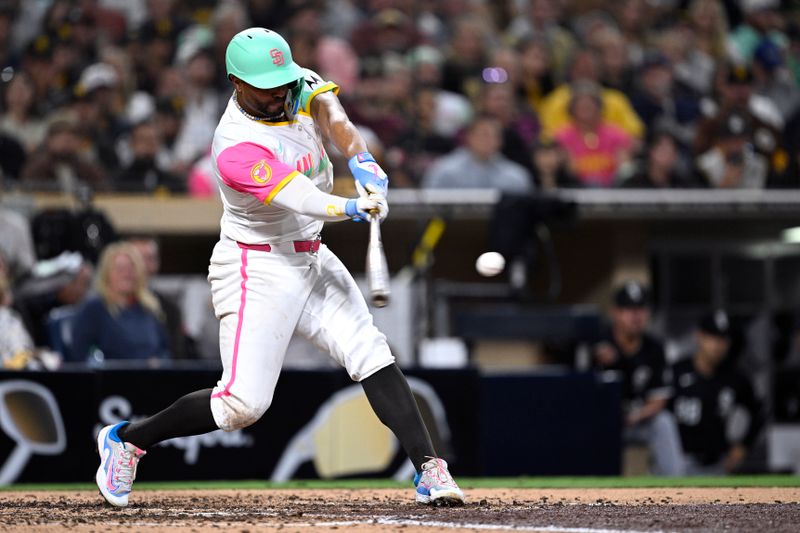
[217, 142, 297, 204]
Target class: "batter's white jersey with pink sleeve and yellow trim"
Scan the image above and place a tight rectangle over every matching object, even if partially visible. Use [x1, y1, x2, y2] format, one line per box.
[211, 69, 339, 244]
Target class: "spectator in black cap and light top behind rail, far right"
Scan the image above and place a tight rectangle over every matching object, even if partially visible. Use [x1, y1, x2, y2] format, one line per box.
[696, 112, 769, 189]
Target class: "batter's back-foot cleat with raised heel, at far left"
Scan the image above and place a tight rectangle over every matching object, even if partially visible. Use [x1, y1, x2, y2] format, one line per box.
[94, 422, 146, 507]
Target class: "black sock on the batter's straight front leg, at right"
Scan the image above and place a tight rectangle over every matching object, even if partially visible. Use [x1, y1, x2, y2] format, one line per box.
[361, 364, 436, 471]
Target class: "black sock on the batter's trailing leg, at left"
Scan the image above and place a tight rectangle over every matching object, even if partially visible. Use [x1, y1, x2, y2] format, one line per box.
[117, 389, 218, 450]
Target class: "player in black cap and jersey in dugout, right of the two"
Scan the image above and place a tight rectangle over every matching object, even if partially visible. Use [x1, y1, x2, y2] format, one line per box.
[670, 310, 763, 475]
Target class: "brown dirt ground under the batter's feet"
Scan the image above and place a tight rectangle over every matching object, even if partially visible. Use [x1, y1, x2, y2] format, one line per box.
[0, 487, 800, 533]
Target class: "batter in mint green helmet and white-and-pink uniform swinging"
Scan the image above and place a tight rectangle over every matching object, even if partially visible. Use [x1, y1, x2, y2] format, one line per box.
[96, 28, 464, 507]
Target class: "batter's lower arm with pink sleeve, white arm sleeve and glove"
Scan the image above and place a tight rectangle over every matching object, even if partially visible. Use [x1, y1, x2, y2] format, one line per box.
[216, 142, 388, 221]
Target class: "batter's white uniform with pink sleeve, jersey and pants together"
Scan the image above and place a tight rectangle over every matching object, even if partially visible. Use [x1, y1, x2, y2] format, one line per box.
[208, 69, 394, 430]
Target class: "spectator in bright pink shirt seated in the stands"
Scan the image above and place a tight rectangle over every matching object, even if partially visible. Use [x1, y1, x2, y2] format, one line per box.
[553, 81, 634, 187]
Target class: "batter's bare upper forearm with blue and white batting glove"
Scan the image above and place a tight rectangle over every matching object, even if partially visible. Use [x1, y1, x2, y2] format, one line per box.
[311, 92, 389, 196]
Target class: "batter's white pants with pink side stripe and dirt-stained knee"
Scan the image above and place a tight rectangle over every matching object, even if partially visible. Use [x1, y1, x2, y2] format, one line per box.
[208, 237, 394, 431]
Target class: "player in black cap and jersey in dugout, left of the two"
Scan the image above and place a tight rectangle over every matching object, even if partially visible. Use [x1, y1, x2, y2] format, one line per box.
[589, 281, 682, 475]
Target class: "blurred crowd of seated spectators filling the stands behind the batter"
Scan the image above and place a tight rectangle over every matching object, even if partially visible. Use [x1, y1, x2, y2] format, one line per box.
[0, 0, 800, 196]
